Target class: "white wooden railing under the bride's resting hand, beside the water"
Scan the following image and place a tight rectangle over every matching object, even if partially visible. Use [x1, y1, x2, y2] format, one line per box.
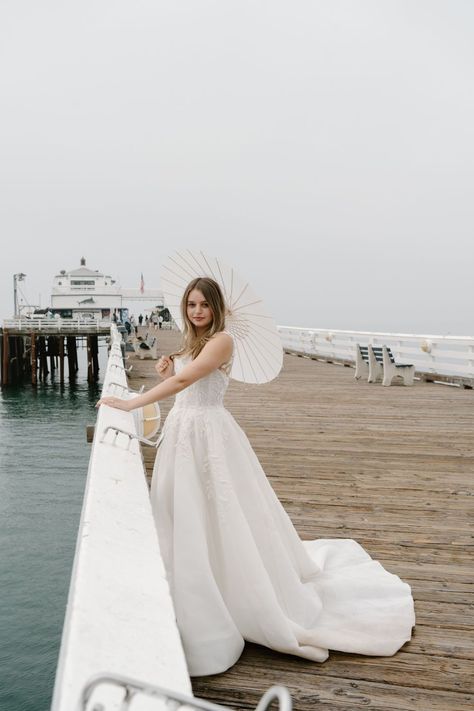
[52, 325, 191, 711]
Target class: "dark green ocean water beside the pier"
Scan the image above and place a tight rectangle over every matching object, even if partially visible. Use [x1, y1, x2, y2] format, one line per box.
[0, 349, 105, 711]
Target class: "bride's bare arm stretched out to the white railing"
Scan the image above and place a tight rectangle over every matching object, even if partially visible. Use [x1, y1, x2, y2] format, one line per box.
[96, 333, 233, 412]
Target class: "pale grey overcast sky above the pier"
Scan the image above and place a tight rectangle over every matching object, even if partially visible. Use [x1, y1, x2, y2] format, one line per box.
[0, 0, 474, 335]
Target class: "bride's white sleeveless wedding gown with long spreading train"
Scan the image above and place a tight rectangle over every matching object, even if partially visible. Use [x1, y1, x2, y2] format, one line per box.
[151, 344, 415, 676]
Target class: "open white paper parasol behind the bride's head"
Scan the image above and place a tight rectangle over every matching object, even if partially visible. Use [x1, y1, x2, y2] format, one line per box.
[161, 250, 283, 383]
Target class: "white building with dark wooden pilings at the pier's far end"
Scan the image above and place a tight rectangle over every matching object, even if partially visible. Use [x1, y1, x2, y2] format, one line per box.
[0, 257, 164, 387]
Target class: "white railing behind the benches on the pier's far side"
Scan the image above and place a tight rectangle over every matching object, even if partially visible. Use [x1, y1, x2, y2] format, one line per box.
[278, 326, 474, 387]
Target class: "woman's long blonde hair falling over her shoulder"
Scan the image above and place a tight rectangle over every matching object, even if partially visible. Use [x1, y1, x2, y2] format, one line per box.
[170, 277, 226, 360]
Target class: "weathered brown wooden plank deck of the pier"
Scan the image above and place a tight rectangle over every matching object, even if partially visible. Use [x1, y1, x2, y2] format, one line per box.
[130, 331, 474, 711]
